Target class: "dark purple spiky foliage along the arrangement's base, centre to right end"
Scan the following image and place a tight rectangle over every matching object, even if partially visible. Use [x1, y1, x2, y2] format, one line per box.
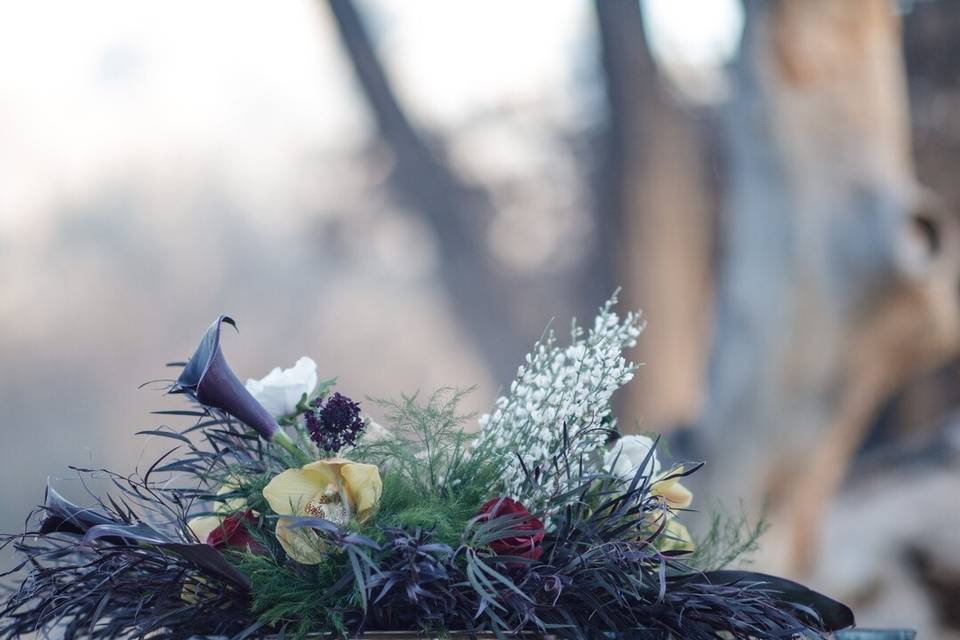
[234, 460, 852, 640]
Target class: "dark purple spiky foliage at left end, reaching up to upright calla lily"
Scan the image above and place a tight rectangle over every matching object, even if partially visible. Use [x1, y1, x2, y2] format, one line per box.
[0, 363, 290, 638]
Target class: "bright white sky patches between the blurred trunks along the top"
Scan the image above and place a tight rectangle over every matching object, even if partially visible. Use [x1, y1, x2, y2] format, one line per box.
[0, 0, 742, 234]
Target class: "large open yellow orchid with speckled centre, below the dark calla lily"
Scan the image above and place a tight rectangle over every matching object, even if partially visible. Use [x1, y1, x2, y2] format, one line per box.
[263, 458, 383, 564]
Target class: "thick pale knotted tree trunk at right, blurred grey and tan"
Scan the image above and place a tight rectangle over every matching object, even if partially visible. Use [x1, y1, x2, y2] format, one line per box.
[702, 0, 960, 572]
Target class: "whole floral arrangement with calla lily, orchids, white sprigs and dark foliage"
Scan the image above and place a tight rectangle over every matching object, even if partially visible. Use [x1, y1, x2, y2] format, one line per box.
[0, 299, 853, 640]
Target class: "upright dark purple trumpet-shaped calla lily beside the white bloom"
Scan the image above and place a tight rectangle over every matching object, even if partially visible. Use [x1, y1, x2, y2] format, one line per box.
[170, 316, 280, 440]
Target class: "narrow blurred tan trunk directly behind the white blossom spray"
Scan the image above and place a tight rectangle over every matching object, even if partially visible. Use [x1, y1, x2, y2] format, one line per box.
[595, 0, 712, 431]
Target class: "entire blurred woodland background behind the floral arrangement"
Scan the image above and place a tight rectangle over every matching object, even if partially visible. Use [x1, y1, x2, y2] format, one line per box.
[0, 0, 960, 639]
